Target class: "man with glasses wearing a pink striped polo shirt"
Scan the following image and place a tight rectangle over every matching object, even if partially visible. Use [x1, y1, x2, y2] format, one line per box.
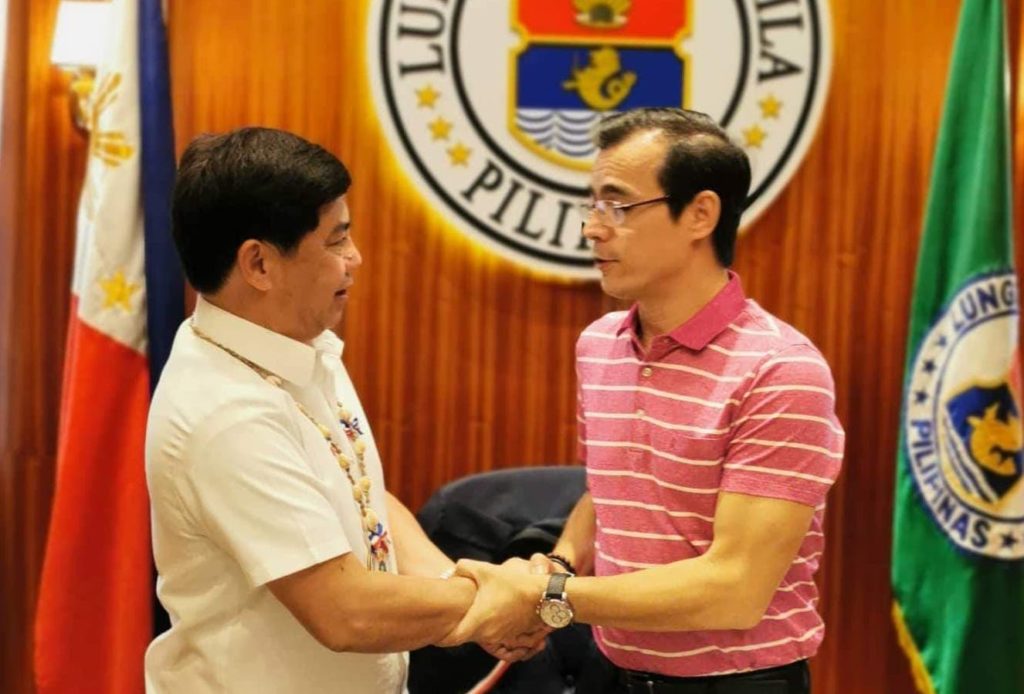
[459, 109, 843, 694]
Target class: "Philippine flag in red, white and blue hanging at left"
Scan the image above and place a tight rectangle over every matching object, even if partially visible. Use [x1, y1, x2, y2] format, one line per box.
[35, 0, 184, 694]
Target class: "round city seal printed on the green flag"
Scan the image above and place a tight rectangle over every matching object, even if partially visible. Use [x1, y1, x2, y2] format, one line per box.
[903, 272, 1024, 559]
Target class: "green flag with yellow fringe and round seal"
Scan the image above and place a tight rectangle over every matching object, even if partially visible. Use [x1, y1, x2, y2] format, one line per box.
[892, 0, 1024, 694]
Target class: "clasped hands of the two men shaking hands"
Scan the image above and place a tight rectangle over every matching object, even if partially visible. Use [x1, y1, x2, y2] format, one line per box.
[437, 554, 567, 662]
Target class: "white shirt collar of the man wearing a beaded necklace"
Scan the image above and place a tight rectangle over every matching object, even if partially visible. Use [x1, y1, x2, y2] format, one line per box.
[191, 296, 344, 388]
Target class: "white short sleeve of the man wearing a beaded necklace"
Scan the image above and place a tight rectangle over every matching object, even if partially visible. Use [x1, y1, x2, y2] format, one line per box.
[188, 402, 351, 585]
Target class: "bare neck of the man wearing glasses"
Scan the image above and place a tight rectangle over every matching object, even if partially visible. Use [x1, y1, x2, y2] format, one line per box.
[637, 267, 729, 350]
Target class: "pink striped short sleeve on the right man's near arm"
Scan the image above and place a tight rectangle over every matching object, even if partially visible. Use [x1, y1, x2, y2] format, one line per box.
[721, 344, 844, 507]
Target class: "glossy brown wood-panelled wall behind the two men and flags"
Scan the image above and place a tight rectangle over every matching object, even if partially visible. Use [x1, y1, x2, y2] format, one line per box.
[0, 0, 1024, 694]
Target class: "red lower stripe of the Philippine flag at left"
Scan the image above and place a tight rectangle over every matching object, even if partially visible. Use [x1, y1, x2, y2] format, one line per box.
[35, 298, 153, 694]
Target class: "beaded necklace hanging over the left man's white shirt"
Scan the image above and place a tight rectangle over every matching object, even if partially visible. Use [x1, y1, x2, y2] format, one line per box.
[190, 322, 391, 571]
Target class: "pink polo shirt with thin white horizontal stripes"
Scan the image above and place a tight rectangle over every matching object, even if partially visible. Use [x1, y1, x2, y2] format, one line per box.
[577, 273, 844, 677]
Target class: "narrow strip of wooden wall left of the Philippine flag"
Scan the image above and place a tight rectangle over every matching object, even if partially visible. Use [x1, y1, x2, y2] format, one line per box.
[0, 0, 85, 693]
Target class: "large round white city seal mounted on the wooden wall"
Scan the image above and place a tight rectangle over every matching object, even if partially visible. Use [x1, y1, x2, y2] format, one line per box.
[368, 0, 831, 277]
